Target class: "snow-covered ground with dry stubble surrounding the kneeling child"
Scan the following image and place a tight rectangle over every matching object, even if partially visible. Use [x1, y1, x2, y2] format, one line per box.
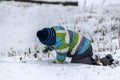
[0, 0, 120, 80]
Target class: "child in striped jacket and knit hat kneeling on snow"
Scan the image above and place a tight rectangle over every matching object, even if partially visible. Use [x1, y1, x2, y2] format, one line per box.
[37, 26, 113, 66]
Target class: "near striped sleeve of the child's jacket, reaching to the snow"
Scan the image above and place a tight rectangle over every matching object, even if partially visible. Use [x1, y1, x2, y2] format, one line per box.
[53, 26, 69, 63]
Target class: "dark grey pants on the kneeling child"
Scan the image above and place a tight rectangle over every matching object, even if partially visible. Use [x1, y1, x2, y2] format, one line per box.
[71, 46, 93, 64]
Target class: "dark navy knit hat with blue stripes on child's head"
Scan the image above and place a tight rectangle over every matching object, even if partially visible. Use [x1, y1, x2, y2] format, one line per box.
[37, 28, 56, 46]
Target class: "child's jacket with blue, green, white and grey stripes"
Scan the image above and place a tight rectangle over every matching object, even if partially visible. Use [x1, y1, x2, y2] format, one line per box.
[52, 26, 91, 62]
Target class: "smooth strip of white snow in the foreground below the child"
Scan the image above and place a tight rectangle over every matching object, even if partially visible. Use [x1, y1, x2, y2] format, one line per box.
[0, 57, 120, 80]
